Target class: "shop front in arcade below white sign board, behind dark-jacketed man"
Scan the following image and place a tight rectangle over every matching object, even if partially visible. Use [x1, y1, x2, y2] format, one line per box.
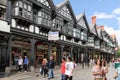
[35, 41, 58, 66]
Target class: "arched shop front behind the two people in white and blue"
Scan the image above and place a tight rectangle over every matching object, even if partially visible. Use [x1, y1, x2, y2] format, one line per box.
[10, 37, 32, 70]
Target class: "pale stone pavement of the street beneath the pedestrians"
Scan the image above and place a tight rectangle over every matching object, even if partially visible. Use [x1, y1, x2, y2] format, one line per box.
[0, 65, 116, 80]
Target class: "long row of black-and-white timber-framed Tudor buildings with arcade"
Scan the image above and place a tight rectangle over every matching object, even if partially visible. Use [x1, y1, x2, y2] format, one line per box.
[0, 0, 117, 75]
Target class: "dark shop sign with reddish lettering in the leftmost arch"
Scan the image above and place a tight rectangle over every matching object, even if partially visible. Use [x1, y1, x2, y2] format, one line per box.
[11, 41, 31, 48]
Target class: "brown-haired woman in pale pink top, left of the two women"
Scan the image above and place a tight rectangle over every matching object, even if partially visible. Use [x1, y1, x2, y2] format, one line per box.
[92, 59, 103, 80]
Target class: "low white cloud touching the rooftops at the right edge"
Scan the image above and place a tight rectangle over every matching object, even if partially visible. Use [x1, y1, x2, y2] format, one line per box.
[105, 26, 120, 45]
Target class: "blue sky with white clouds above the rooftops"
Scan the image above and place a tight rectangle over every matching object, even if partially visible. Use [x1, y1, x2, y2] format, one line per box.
[53, 0, 120, 45]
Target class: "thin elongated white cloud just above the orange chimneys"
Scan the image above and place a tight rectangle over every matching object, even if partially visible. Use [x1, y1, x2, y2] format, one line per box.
[94, 12, 114, 19]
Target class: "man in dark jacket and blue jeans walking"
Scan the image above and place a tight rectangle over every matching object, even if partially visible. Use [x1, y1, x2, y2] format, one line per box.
[48, 56, 55, 79]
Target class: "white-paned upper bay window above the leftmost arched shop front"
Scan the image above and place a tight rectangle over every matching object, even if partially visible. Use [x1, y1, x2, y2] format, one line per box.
[13, 1, 32, 20]
